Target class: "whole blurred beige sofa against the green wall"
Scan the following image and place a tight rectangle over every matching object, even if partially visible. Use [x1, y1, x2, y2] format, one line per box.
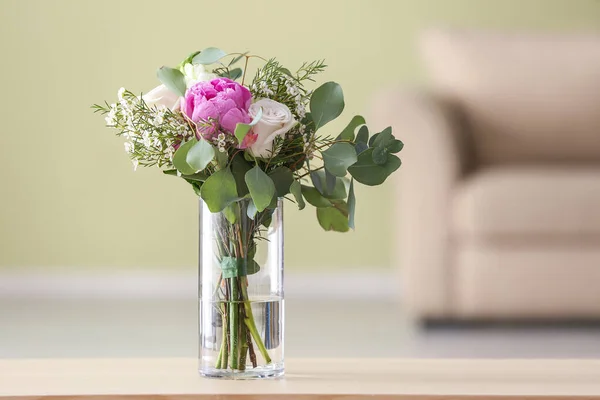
[372, 31, 600, 319]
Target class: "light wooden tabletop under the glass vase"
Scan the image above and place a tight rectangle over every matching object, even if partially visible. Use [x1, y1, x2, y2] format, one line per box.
[0, 358, 600, 400]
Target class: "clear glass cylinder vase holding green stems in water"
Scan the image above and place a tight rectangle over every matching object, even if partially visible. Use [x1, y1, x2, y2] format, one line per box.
[198, 199, 284, 379]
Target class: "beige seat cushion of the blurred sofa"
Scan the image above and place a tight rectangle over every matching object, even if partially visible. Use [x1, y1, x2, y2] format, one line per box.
[452, 167, 600, 239]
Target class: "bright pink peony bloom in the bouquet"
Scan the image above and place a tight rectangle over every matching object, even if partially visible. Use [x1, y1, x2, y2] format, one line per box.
[181, 78, 252, 139]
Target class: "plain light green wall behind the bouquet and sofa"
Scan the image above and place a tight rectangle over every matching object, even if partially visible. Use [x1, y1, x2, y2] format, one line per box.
[0, 0, 600, 269]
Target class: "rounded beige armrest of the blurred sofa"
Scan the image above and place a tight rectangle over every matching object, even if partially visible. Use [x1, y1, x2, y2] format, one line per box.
[369, 90, 472, 318]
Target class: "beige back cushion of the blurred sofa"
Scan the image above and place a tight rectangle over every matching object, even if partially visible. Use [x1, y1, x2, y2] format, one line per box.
[422, 31, 600, 164]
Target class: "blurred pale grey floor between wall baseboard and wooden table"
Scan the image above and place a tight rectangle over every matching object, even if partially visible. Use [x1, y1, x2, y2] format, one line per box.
[0, 298, 600, 358]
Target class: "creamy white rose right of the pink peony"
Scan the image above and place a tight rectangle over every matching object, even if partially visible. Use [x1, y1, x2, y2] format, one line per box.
[248, 99, 297, 158]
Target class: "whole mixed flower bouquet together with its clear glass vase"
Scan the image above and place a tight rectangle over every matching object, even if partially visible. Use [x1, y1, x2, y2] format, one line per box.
[93, 47, 403, 378]
